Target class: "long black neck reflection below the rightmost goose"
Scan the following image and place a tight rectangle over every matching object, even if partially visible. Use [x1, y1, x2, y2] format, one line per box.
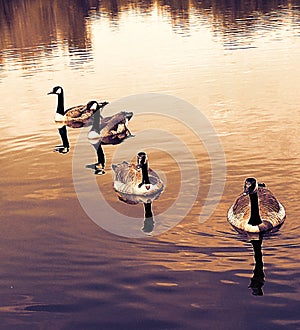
[248, 236, 265, 296]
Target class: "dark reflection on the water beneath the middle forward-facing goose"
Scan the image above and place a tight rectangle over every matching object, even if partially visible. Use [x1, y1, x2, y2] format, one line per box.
[116, 191, 160, 235]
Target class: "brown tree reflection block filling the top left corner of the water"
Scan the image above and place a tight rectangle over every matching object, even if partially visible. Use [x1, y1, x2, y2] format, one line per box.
[0, 0, 97, 68]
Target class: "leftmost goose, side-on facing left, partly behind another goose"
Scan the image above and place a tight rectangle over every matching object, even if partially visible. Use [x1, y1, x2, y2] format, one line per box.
[48, 86, 108, 124]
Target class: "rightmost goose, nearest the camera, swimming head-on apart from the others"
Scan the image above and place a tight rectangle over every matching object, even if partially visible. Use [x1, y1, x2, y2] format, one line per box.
[227, 178, 285, 233]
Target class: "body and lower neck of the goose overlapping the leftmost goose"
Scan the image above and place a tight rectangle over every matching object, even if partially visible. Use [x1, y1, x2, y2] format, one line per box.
[88, 104, 133, 144]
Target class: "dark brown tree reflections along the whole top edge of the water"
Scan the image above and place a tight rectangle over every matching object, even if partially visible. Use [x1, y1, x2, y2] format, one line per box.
[0, 0, 299, 68]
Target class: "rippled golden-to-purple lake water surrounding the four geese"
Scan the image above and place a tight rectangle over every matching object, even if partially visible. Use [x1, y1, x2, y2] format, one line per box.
[0, 0, 300, 330]
